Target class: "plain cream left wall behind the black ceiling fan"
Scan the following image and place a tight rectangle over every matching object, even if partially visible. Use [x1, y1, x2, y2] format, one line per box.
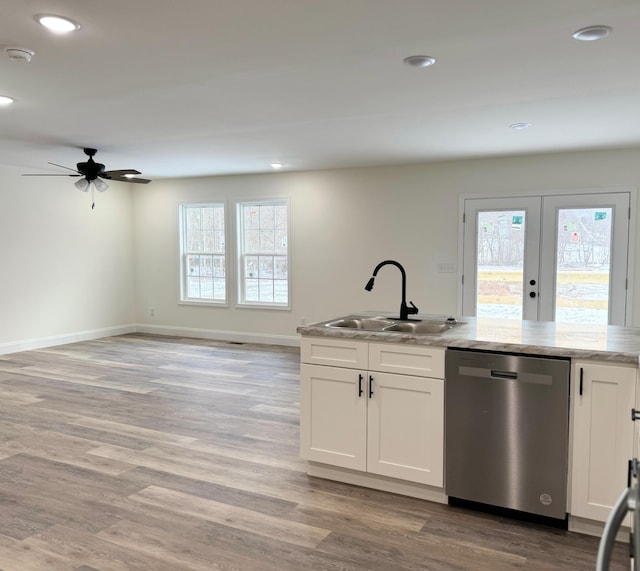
[0, 166, 134, 353]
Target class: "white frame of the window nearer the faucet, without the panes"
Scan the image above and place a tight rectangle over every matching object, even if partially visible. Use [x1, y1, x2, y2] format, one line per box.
[234, 198, 291, 310]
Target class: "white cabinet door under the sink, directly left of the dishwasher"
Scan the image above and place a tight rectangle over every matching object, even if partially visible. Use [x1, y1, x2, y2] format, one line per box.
[367, 372, 444, 487]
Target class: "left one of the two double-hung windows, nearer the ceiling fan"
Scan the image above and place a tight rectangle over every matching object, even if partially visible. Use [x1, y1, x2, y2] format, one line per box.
[180, 203, 227, 304]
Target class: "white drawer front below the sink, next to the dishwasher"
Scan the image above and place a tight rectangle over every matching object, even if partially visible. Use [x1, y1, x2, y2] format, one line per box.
[369, 343, 445, 379]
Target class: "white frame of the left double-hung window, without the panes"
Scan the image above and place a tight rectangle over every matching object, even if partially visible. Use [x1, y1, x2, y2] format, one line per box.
[178, 201, 232, 307]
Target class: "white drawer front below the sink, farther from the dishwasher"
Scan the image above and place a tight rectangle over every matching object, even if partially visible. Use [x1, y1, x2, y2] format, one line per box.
[300, 337, 368, 369]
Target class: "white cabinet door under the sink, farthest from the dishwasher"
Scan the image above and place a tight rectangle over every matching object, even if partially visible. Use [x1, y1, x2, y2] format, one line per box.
[300, 364, 367, 471]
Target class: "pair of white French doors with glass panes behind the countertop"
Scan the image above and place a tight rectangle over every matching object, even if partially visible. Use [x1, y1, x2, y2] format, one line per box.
[462, 192, 631, 325]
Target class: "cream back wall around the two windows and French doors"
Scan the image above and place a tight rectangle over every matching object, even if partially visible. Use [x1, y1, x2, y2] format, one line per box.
[133, 149, 640, 343]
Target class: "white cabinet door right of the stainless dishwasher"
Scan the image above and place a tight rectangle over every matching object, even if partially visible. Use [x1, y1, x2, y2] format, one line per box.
[570, 361, 636, 521]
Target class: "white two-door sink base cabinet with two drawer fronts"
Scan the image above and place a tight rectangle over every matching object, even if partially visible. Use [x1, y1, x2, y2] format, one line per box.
[300, 338, 444, 487]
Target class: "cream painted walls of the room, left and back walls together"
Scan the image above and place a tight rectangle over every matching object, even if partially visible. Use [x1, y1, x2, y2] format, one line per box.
[0, 149, 640, 353]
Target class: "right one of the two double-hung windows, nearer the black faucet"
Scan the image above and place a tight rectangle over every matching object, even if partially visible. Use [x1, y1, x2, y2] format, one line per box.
[237, 200, 289, 307]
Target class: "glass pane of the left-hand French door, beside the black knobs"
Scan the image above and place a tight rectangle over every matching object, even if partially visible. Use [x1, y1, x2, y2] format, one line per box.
[476, 210, 525, 319]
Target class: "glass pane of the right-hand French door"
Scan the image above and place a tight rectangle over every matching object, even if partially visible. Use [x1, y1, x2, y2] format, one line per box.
[555, 208, 613, 325]
